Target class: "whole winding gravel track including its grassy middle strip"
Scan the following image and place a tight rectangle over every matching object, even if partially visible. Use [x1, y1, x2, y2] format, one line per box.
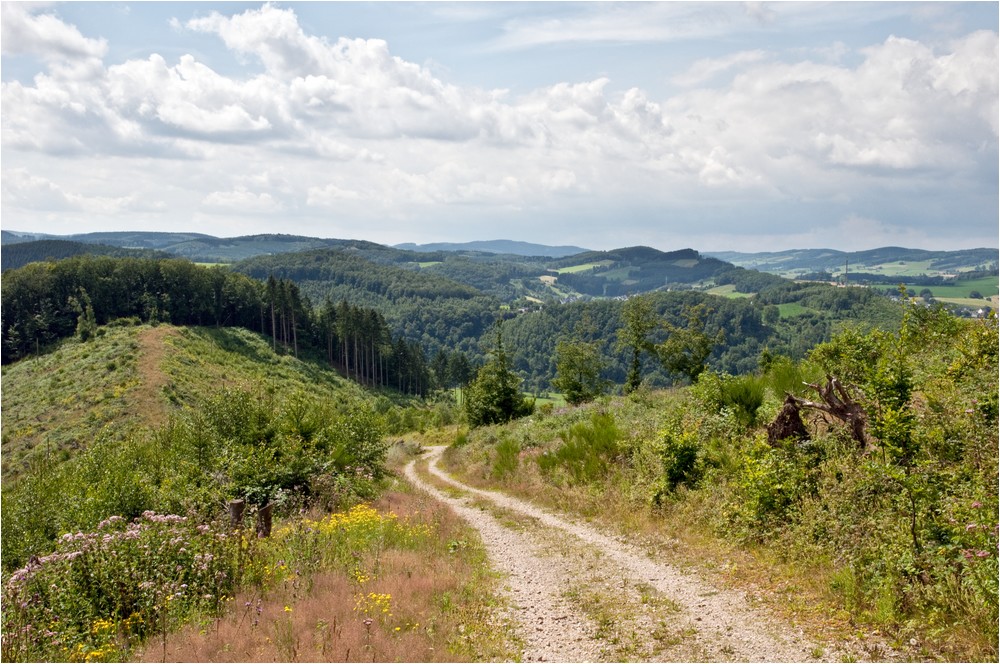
[405, 447, 880, 662]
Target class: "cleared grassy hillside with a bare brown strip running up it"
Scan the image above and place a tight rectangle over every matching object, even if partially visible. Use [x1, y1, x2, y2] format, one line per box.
[2, 325, 368, 481]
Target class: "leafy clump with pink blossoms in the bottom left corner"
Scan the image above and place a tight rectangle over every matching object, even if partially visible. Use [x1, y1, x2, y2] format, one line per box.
[3, 511, 240, 662]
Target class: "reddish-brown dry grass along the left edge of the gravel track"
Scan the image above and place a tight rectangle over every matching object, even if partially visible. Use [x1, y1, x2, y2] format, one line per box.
[140, 492, 516, 662]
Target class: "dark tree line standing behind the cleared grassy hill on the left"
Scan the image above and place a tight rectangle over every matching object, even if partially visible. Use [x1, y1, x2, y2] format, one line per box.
[0, 256, 458, 395]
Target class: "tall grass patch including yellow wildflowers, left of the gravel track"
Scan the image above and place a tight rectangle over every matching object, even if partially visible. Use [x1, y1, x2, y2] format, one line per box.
[140, 493, 517, 662]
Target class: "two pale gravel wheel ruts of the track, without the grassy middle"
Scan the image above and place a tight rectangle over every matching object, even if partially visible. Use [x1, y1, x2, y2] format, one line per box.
[405, 447, 880, 662]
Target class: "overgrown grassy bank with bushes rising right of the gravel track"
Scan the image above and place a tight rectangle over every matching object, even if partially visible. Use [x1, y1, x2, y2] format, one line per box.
[446, 312, 998, 661]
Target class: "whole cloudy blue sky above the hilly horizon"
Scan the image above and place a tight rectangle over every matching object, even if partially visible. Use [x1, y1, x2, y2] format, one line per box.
[0, 2, 1000, 252]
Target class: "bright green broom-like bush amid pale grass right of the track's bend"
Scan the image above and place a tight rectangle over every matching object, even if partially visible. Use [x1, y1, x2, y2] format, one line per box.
[537, 412, 622, 484]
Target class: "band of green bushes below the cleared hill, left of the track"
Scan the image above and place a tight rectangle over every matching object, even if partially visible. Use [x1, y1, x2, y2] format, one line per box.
[2, 389, 387, 569]
